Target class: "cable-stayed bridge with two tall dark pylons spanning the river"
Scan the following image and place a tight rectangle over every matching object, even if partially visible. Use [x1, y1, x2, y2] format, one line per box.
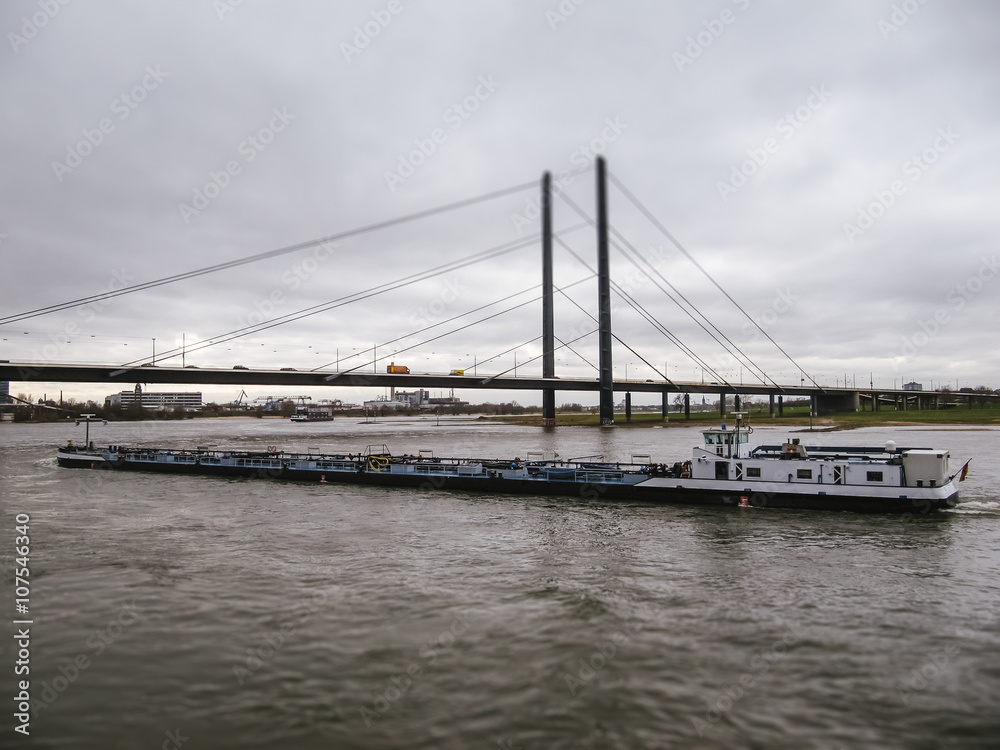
[0, 157, 968, 424]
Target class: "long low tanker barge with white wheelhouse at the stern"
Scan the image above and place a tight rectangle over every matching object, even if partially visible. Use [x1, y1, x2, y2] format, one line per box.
[56, 422, 968, 514]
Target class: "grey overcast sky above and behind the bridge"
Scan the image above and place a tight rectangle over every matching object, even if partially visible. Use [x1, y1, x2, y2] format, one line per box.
[0, 0, 1000, 403]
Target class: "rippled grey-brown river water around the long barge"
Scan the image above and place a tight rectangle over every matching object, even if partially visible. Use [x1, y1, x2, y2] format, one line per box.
[0, 418, 1000, 750]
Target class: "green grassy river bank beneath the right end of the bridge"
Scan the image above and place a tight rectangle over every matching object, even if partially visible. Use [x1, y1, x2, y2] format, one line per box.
[480, 406, 1000, 430]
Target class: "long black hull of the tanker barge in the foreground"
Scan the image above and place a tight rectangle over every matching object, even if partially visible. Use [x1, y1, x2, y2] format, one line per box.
[58, 456, 958, 515]
